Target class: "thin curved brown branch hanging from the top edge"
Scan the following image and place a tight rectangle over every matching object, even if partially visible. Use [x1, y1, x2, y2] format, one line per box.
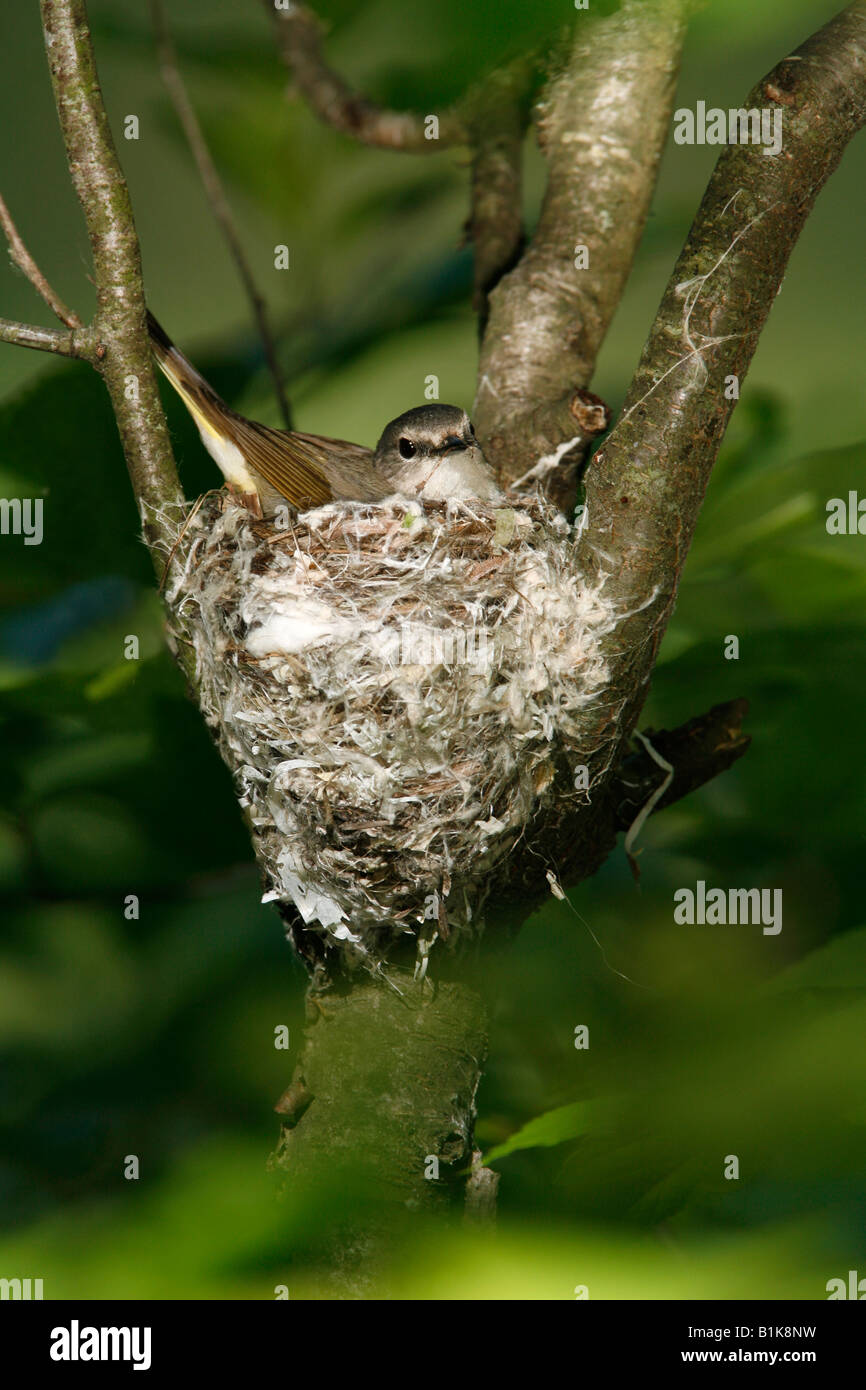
[264, 0, 466, 154]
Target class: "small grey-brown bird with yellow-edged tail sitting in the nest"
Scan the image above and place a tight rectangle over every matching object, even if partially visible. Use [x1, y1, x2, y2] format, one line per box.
[147, 310, 502, 517]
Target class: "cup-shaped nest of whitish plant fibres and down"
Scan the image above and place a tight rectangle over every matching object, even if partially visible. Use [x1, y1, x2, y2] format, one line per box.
[170, 495, 620, 969]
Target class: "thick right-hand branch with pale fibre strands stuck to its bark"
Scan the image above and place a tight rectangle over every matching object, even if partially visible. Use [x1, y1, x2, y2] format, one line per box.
[577, 0, 866, 746]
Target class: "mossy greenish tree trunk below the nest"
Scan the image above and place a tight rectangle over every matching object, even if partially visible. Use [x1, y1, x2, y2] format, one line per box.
[272, 970, 487, 1297]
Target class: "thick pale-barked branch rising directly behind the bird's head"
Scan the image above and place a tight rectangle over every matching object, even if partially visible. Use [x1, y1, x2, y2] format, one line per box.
[474, 0, 687, 506]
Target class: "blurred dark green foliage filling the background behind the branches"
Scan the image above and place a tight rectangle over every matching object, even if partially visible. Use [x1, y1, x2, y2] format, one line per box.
[0, 0, 866, 1298]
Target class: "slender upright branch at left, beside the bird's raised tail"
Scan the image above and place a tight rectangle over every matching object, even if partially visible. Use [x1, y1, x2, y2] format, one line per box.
[42, 0, 183, 577]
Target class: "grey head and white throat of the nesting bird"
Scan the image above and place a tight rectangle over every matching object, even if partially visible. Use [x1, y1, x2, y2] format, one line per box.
[374, 404, 500, 500]
